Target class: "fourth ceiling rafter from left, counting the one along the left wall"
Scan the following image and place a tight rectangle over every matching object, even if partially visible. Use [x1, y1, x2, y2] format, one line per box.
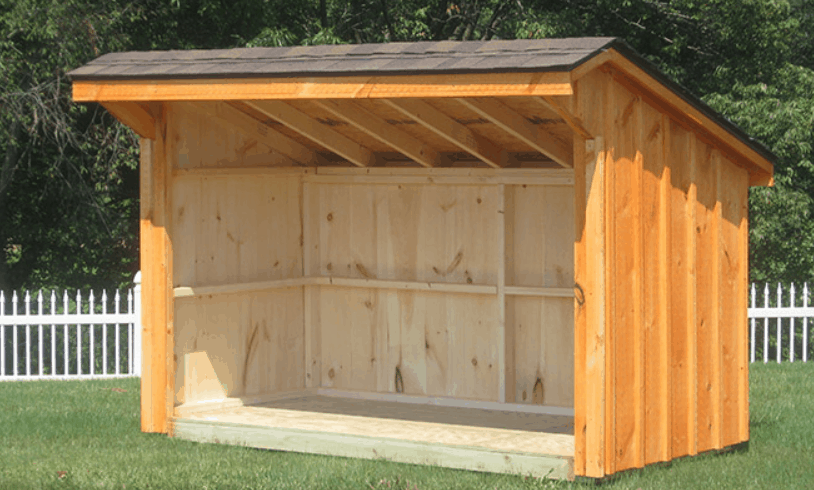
[383, 99, 508, 168]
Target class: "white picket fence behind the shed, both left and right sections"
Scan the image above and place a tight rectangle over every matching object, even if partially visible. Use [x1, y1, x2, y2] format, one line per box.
[0, 273, 814, 381]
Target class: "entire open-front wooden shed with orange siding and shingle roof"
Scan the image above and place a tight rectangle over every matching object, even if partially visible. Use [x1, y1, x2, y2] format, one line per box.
[71, 38, 773, 478]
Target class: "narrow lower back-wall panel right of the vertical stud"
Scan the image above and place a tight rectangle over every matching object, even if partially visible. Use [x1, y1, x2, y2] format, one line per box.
[507, 298, 574, 407]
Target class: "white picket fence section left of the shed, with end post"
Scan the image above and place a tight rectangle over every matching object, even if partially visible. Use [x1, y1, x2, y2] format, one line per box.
[0, 273, 141, 381]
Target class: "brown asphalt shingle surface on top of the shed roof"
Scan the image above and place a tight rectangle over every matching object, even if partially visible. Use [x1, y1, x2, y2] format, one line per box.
[68, 37, 619, 80]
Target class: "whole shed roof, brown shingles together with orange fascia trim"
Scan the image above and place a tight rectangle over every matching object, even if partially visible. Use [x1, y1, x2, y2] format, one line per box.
[68, 37, 777, 182]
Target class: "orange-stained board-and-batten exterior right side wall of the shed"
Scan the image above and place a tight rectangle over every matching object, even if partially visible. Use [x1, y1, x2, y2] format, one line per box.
[575, 70, 749, 477]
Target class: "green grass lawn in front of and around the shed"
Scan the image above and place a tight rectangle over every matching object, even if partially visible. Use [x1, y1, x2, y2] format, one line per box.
[0, 363, 814, 490]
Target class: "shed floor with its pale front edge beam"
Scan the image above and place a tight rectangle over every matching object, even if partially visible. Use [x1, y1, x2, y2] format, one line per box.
[174, 393, 574, 479]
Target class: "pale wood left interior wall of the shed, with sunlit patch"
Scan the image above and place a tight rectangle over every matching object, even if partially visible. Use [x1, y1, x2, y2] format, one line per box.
[168, 104, 304, 404]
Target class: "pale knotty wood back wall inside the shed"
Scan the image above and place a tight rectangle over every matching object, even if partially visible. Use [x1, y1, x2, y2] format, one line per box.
[306, 179, 574, 407]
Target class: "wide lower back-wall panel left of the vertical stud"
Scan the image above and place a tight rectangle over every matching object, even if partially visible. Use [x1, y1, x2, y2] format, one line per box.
[320, 286, 498, 401]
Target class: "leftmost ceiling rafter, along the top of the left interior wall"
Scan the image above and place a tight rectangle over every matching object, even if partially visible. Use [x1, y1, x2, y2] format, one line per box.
[189, 102, 324, 165]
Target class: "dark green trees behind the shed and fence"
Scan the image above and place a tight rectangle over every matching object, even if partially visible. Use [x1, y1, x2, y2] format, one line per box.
[0, 0, 814, 289]
